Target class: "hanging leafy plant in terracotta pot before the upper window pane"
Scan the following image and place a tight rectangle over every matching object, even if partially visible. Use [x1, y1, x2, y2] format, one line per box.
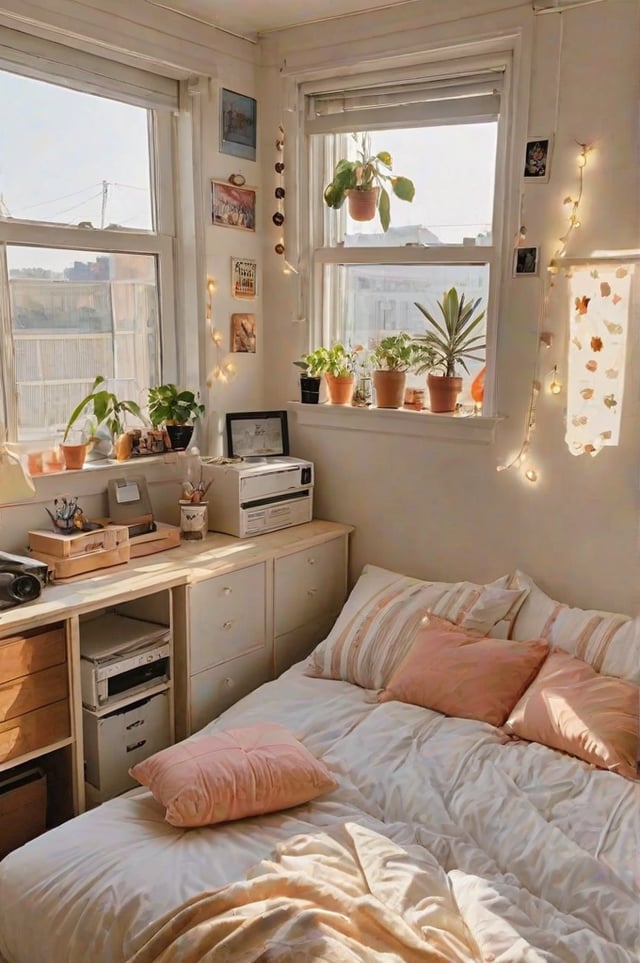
[324, 134, 416, 232]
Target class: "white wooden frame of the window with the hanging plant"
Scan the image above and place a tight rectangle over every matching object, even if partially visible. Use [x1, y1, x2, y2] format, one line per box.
[297, 38, 517, 417]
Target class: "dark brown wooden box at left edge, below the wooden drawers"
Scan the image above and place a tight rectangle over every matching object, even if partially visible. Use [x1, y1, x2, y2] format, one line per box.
[0, 768, 47, 859]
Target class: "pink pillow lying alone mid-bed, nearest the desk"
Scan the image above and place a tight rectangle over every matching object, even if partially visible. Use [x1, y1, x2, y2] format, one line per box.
[129, 723, 337, 826]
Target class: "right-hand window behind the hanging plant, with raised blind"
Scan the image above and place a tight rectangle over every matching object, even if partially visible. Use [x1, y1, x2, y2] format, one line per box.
[301, 54, 509, 412]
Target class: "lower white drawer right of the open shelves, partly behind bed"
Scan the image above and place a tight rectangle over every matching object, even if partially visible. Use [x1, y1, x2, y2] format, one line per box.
[190, 651, 271, 732]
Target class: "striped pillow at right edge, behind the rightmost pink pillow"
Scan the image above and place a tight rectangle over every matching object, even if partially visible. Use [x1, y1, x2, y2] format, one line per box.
[511, 571, 640, 685]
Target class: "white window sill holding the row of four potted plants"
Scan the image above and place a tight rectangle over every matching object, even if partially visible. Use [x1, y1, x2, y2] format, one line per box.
[288, 401, 502, 445]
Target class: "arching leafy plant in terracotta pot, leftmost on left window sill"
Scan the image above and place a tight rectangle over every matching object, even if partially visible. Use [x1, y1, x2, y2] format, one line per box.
[60, 375, 145, 469]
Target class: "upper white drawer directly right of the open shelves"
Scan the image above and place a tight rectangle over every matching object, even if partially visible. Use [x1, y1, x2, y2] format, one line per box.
[189, 564, 267, 675]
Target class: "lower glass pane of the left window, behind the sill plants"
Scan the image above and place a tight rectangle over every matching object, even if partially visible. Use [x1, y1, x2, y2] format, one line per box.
[7, 246, 160, 439]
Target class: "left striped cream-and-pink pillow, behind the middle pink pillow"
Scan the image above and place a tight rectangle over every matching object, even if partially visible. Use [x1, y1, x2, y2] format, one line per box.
[305, 565, 526, 689]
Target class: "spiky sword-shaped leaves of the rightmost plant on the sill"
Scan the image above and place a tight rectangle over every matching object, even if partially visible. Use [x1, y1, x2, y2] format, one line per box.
[414, 287, 486, 377]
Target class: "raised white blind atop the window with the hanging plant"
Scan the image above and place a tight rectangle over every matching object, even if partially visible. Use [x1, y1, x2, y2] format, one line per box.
[306, 70, 504, 134]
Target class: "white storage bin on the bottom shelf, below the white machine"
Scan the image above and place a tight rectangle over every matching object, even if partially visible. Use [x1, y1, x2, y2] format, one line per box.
[82, 690, 171, 802]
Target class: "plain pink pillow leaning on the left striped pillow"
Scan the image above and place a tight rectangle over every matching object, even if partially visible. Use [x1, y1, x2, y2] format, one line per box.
[378, 616, 549, 726]
